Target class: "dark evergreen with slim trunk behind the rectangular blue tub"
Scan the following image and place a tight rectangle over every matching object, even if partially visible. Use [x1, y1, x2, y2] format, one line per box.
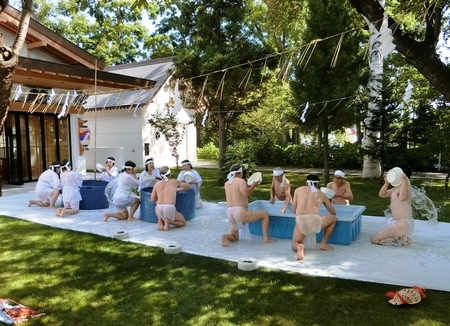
[292, 0, 364, 182]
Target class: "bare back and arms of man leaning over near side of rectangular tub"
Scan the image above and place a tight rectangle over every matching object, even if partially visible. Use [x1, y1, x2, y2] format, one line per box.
[292, 186, 336, 215]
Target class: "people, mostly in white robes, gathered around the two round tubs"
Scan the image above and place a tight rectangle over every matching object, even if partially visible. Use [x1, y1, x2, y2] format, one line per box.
[28, 157, 203, 230]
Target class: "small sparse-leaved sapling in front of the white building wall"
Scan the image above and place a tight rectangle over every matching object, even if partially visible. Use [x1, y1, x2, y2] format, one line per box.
[148, 108, 185, 167]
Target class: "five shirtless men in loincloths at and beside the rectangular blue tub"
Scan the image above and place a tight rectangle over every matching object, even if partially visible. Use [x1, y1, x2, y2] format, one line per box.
[221, 164, 413, 260]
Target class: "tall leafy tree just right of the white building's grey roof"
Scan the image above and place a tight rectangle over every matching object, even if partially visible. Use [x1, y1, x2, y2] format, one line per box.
[158, 0, 276, 166]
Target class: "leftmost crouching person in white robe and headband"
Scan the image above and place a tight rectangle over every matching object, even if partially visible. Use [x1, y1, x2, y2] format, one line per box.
[28, 161, 63, 208]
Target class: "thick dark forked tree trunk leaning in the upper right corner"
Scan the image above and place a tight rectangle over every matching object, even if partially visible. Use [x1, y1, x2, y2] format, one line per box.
[348, 0, 450, 101]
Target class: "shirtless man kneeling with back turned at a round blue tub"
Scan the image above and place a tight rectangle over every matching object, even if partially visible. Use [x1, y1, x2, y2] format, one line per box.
[150, 166, 191, 231]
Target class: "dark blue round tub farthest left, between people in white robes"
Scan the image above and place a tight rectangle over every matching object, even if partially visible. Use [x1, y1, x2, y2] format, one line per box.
[80, 180, 109, 210]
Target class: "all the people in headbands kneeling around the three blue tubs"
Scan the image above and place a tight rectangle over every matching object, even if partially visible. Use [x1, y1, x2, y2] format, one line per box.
[28, 157, 413, 260]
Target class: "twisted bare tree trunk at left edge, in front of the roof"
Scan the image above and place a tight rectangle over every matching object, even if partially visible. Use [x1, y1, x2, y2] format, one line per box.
[0, 0, 33, 131]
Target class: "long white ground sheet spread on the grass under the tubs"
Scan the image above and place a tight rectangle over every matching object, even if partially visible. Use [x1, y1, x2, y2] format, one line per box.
[0, 192, 450, 291]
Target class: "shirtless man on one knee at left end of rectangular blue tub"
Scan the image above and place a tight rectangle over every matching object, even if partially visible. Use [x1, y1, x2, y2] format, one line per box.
[221, 164, 275, 247]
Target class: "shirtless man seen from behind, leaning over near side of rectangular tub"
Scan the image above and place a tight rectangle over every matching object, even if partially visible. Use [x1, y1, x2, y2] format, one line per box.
[292, 174, 336, 260]
